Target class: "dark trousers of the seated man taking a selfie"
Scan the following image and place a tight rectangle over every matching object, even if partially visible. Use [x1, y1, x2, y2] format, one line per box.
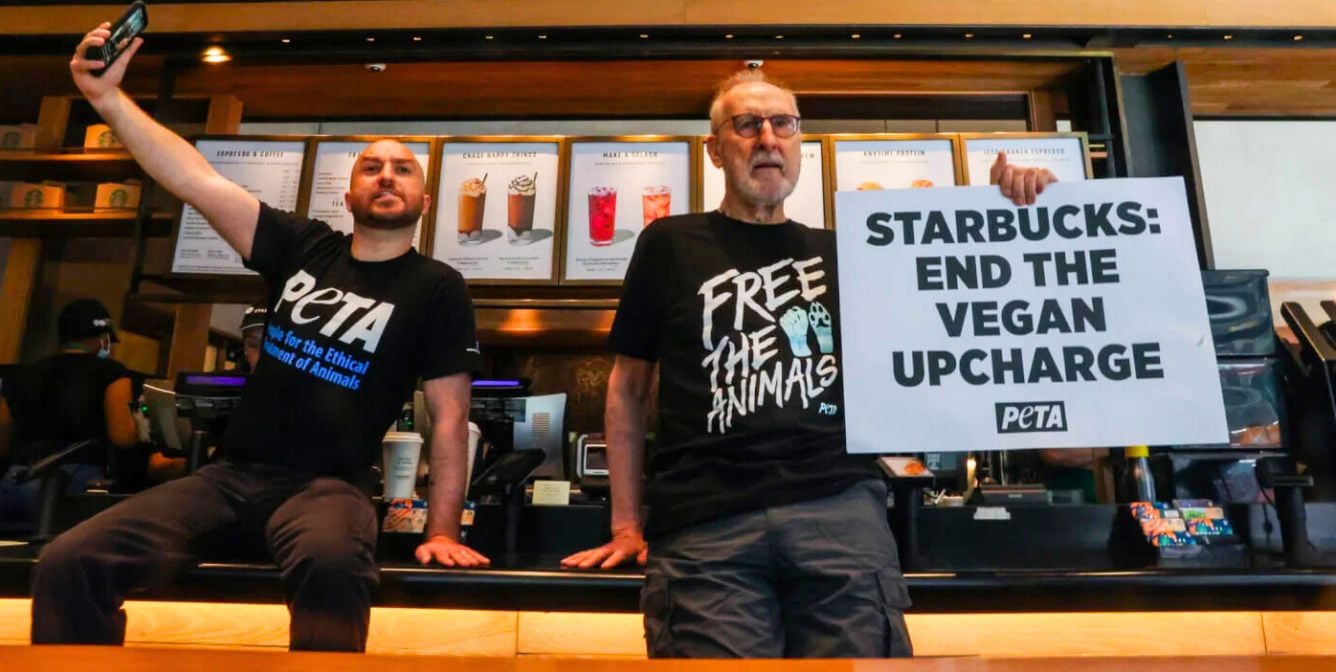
[32, 461, 379, 651]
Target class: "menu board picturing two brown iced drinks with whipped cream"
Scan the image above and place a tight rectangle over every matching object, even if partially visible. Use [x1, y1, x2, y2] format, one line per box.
[432, 140, 561, 281]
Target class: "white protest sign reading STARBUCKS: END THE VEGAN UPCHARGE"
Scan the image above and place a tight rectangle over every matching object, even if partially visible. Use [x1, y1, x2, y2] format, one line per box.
[835, 178, 1228, 453]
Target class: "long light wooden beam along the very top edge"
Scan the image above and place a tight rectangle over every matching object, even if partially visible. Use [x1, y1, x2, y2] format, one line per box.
[0, 0, 1336, 36]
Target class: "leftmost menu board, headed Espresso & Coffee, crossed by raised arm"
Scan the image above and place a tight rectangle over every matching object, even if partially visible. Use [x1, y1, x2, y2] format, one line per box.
[171, 138, 306, 275]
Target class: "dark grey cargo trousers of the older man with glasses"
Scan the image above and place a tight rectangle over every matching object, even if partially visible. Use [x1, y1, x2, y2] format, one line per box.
[640, 481, 914, 657]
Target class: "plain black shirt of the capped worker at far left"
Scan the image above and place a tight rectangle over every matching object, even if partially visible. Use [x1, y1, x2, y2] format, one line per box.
[4, 353, 130, 468]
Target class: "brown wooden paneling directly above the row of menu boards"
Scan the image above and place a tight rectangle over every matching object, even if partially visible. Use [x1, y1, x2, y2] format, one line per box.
[169, 60, 1081, 119]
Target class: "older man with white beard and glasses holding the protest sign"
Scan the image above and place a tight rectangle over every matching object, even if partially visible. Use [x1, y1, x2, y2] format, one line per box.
[564, 71, 1053, 657]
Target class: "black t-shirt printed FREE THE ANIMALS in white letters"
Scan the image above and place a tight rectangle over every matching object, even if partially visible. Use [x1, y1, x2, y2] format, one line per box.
[611, 212, 875, 537]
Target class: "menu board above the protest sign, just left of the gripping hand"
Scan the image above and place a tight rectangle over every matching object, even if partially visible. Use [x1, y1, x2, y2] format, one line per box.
[832, 138, 955, 191]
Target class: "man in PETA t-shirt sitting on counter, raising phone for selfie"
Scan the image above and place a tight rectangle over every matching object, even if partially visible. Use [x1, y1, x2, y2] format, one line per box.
[32, 19, 488, 651]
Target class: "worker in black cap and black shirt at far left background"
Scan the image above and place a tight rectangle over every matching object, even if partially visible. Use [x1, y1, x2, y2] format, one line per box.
[0, 299, 140, 531]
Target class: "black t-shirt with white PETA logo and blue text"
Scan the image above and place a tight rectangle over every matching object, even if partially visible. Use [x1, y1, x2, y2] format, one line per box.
[222, 204, 478, 477]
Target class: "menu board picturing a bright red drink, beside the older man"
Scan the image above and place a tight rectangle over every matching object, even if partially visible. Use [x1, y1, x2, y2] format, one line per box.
[562, 139, 692, 282]
